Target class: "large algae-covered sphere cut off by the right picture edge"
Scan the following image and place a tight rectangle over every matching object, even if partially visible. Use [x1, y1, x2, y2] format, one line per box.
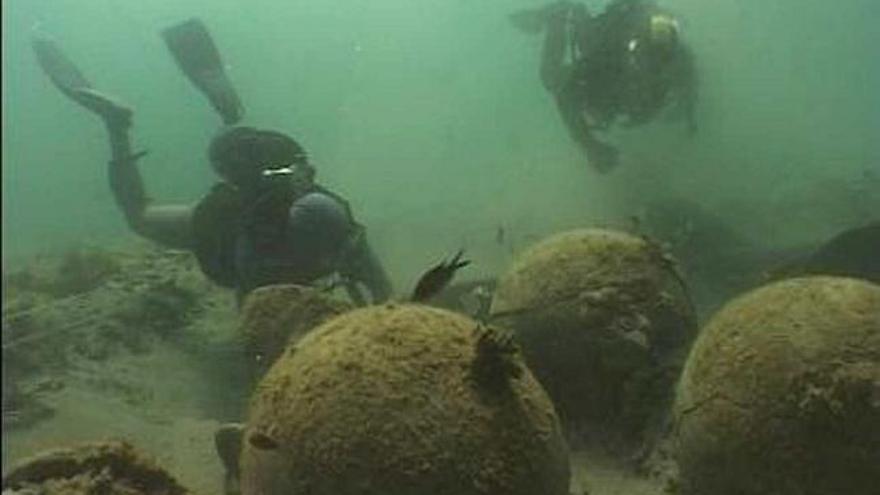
[674, 277, 880, 495]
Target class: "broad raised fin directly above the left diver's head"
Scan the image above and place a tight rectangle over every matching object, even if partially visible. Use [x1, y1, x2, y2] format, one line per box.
[162, 18, 244, 125]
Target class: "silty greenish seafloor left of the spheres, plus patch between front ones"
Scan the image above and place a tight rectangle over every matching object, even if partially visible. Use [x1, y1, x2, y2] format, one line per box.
[3, 245, 667, 495]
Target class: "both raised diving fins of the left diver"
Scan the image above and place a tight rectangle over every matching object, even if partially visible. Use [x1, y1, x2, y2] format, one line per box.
[32, 18, 244, 125]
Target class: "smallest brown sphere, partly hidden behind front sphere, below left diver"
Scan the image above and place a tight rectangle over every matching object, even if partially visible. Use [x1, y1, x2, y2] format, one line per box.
[240, 284, 353, 367]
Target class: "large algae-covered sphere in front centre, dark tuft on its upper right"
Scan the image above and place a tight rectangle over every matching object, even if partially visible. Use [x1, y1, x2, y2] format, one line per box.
[240, 305, 569, 495]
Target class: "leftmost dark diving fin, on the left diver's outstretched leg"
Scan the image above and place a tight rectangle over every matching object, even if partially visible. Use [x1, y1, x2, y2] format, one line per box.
[31, 34, 132, 126]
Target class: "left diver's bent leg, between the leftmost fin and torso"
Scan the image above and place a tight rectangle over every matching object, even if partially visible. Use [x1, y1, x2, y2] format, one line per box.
[105, 117, 192, 249]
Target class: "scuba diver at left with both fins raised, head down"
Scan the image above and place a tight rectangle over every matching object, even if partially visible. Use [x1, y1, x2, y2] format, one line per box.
[33, 19, 391, 305]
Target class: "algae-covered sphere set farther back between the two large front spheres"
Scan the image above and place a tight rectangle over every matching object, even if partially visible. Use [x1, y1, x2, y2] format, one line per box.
[491, 229, 696, 441]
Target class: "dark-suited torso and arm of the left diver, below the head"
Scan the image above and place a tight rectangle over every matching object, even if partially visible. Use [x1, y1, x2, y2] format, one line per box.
[192, 174, 391, 303]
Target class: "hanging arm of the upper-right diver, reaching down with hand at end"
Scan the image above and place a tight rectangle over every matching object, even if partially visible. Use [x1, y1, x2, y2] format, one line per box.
[555, 79, 618, 173]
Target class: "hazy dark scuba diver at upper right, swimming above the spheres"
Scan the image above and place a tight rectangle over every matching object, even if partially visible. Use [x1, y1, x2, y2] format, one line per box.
[510, 0, 696, 173]
